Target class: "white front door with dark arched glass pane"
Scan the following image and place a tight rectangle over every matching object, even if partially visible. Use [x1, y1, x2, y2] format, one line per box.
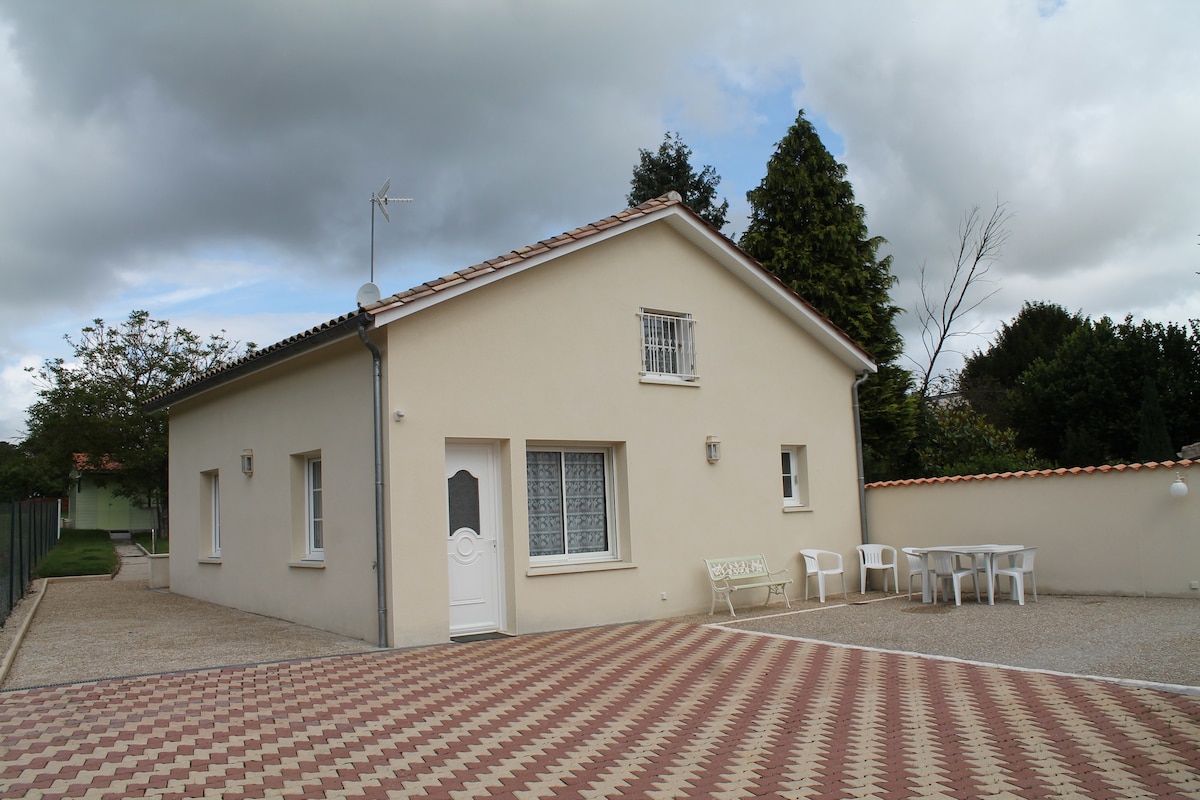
[444, 444, 502, 636]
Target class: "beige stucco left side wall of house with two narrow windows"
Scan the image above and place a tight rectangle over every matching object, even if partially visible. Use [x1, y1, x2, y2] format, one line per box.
[170, 336, 378, 640]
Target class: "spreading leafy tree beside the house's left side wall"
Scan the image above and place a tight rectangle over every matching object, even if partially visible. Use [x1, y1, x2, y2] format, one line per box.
[23, 311, 254, 528]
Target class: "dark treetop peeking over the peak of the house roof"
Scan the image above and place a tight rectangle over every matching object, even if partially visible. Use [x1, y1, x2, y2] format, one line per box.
[625, 133, 730, 230]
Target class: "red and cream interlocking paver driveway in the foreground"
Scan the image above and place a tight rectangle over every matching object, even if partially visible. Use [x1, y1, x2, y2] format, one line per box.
[0, 621, 1200, 800]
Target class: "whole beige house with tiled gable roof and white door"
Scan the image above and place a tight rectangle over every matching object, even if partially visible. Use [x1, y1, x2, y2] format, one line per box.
[149, 193, 876, 645]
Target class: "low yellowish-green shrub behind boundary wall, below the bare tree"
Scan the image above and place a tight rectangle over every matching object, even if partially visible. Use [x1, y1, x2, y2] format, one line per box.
[918, 399, 1049, 477]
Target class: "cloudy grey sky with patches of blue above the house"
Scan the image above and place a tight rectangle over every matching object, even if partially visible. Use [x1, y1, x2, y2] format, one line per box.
[0, 0, 1200, 440]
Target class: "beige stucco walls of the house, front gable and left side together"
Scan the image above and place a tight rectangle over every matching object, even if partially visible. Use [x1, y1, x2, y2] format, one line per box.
[170, 224, 859, 646]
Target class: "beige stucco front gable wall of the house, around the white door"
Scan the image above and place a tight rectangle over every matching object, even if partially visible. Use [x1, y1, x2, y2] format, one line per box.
[386, 225, 859, 644]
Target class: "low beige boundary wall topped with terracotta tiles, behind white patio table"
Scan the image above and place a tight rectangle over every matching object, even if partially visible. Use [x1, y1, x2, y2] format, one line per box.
[866, 462, 1200, 597]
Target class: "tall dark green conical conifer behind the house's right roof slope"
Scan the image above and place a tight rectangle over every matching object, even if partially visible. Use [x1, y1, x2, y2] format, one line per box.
[739, 110, 916, 480]
